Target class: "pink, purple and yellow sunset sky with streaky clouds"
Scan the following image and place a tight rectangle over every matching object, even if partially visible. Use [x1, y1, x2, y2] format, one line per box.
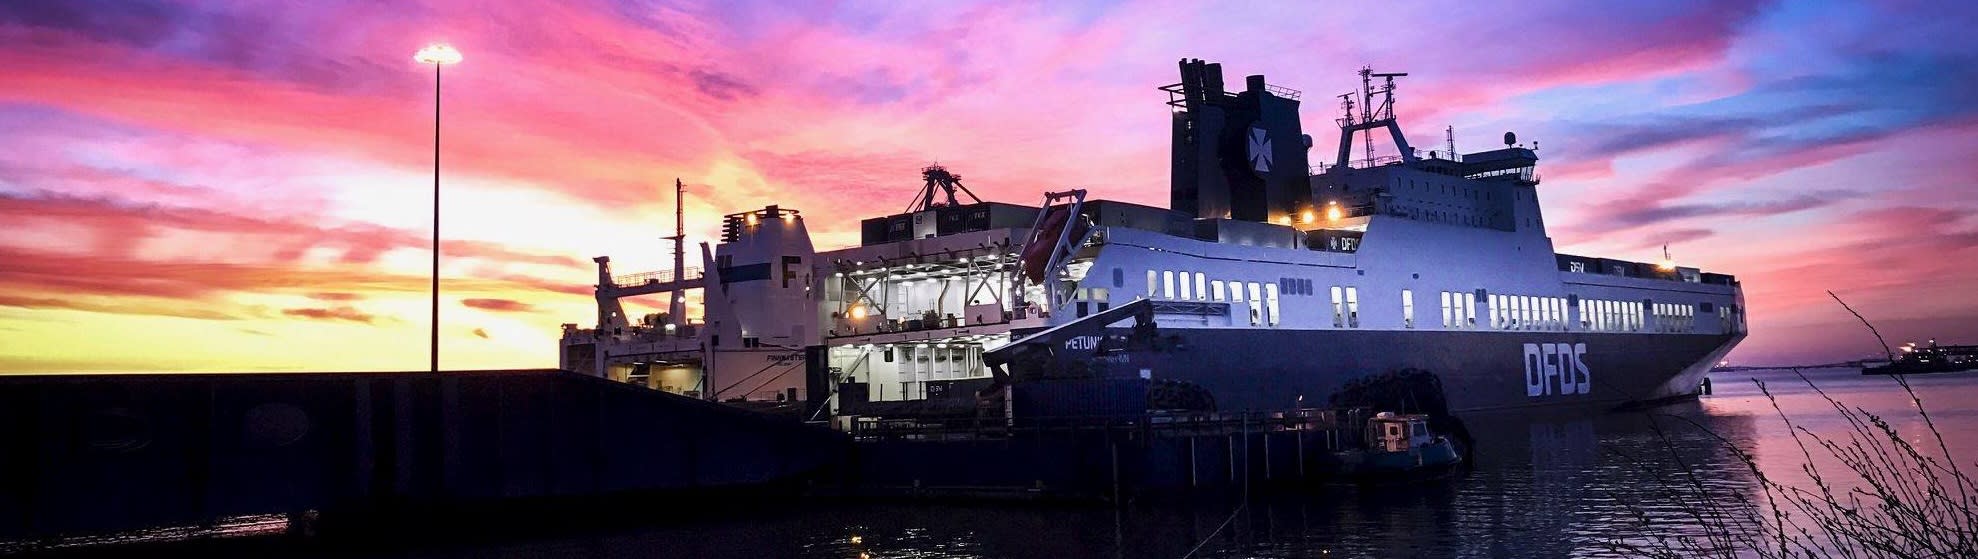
[0, 0, 1978, 371]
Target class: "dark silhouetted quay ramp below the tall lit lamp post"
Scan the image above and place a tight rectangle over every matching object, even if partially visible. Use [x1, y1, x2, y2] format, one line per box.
[0, 369, 851, 543]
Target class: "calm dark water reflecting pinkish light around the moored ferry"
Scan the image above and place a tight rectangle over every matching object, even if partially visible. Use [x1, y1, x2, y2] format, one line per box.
[54, 369, 1978, 557]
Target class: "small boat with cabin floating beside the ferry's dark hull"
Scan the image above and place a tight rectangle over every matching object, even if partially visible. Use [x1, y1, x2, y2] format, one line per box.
[1333, 411, 1464, 478]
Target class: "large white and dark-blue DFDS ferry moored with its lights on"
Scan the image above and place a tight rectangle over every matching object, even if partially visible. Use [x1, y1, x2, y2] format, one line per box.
[560, 59, 1745, 417]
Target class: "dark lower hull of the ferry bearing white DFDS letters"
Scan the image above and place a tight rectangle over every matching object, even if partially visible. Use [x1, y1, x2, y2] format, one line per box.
[1122, 328, 1743, 413]
